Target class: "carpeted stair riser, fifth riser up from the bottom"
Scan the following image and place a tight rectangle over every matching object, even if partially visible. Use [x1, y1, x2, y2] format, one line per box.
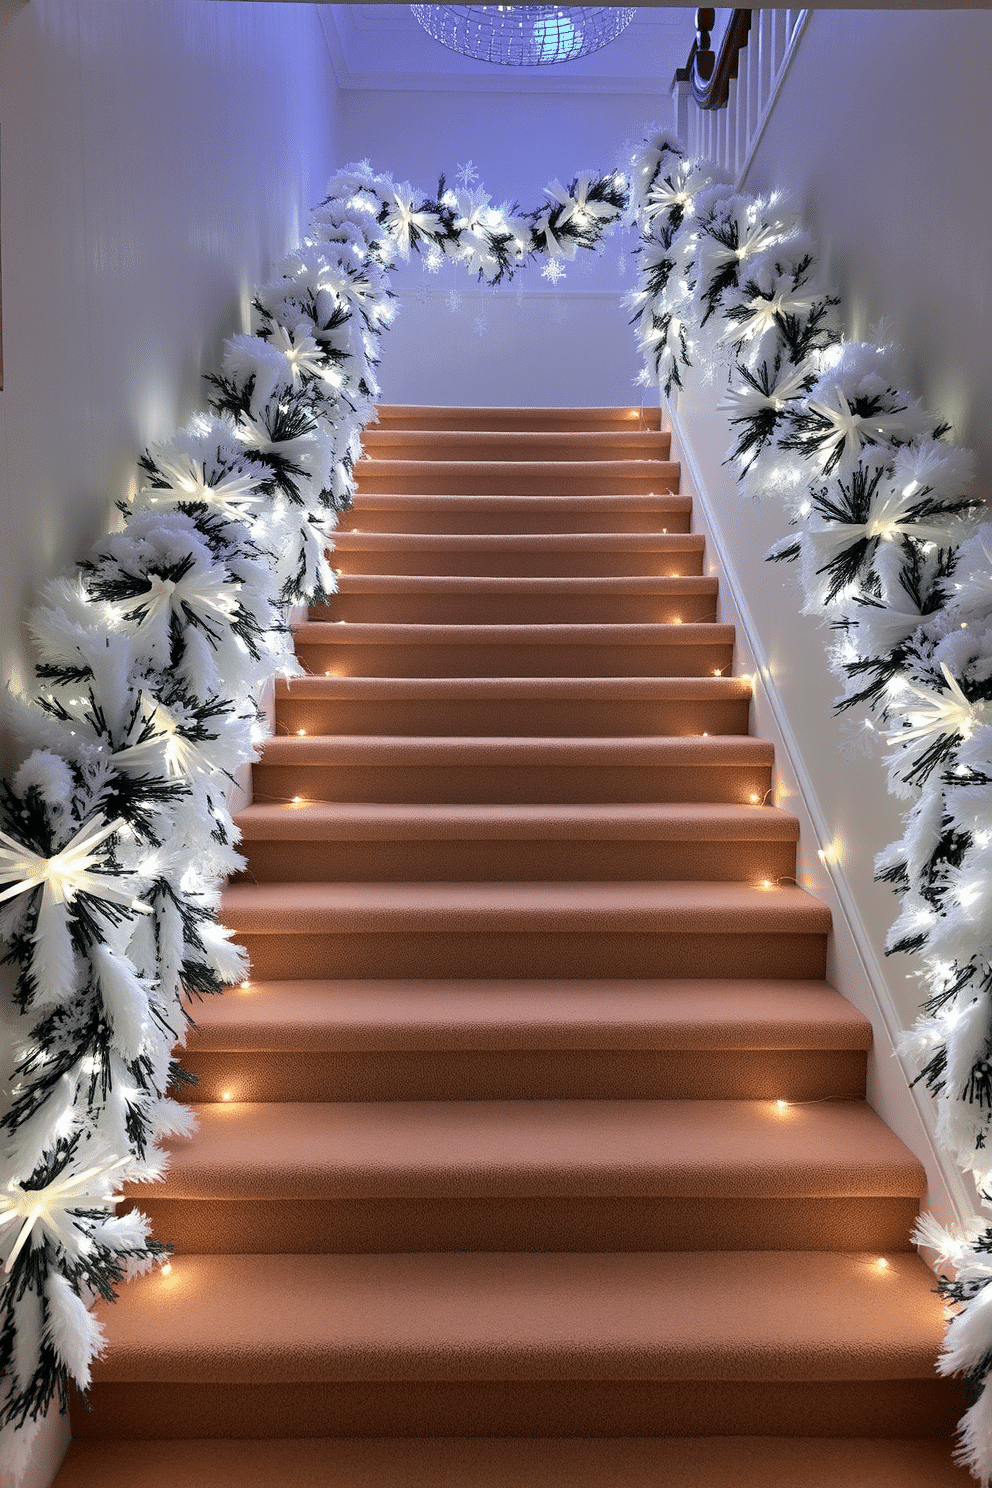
[235, 838, 796, 884]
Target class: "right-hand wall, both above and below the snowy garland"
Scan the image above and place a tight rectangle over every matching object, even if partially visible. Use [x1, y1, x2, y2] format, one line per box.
[678, 10, 992, 1217]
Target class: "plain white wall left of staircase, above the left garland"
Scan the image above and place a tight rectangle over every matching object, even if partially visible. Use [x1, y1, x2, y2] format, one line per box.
[0, 0, 339, 1488]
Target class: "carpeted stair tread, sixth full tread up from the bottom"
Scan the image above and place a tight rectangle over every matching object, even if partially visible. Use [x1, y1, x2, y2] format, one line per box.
[262, 735, 775, 769]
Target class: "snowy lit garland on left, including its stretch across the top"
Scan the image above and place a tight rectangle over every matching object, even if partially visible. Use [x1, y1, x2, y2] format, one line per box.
[0, 162, 626, 1476]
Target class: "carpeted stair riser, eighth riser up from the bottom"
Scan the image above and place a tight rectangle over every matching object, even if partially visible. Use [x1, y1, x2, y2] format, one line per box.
[296, 642, 733, 677]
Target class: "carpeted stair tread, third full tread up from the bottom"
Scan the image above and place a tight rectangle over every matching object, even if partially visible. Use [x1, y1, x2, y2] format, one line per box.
[190, 978, 872, 1052]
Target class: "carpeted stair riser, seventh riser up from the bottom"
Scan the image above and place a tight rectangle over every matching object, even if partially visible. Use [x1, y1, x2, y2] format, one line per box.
[275, 693, 751, 741]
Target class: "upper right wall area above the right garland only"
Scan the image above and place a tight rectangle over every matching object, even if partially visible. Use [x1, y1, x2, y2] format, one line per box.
[744, 9, 992, 478]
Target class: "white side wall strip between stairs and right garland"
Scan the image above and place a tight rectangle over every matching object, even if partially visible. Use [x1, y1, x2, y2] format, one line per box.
[662, 372, 974, 1243]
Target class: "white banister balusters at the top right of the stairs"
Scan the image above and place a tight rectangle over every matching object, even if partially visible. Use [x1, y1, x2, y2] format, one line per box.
[672, 10, 809, 183]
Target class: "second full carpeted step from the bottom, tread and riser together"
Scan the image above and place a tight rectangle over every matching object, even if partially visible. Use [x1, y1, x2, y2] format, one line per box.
[132, 1100, 925, 1254]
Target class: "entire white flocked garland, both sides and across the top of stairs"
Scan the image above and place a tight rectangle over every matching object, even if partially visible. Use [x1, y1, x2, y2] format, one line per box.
[0, 134, 992, 1488]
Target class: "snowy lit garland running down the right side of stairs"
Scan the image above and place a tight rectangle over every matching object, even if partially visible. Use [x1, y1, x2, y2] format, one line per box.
[629, 134, 992, 1488]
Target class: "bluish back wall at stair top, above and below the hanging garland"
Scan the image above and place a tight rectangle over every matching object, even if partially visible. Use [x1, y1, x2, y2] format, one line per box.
[341, 87, 671, 405]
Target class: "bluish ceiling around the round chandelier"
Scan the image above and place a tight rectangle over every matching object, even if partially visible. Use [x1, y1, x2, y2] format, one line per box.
[320, 4, 695, 94]
